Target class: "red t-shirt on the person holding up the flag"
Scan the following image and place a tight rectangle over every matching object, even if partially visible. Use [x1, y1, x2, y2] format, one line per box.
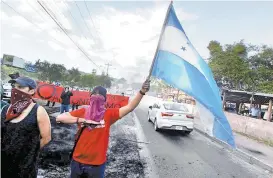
[70, 108, 119, 165]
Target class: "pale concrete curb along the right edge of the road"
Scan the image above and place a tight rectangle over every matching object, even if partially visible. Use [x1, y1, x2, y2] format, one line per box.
[194, 127, 273, 173]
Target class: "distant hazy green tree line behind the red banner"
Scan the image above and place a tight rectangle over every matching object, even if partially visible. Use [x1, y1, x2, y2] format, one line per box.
[1, 60, 111, 88]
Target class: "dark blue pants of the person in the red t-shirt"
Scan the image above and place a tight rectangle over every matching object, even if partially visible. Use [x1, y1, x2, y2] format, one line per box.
[70, 159, 105, 178]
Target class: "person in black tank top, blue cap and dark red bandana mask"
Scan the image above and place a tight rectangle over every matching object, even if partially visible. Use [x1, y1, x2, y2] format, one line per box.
[1, 77, 51, 178]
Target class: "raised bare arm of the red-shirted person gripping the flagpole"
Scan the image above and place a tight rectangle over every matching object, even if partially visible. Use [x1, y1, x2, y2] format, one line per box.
[119, 80, 150, 118]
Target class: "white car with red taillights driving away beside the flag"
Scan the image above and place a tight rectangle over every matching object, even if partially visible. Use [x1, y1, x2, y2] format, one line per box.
[148, 101, 194, 134]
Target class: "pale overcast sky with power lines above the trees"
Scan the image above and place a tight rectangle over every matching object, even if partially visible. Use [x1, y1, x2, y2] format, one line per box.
[0, 0, 273, 81]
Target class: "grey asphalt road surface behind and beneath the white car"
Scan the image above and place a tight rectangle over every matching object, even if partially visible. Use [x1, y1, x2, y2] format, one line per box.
[135, 102, 271, 178]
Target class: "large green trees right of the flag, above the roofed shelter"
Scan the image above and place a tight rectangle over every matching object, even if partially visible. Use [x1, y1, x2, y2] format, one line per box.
[208, 40, 273, 93]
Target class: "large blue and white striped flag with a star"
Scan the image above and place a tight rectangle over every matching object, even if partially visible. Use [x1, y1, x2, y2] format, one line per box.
[151, 3, 235, 147]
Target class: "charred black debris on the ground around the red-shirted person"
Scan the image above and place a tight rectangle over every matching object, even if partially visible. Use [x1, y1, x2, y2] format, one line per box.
[38, 108, 146, 178]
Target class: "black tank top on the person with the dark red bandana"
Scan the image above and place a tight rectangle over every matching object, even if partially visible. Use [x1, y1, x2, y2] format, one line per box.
[1, 104, 40, 178]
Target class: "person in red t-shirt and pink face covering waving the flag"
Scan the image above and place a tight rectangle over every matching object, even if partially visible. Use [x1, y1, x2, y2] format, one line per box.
[56, 80, 150, 178]
